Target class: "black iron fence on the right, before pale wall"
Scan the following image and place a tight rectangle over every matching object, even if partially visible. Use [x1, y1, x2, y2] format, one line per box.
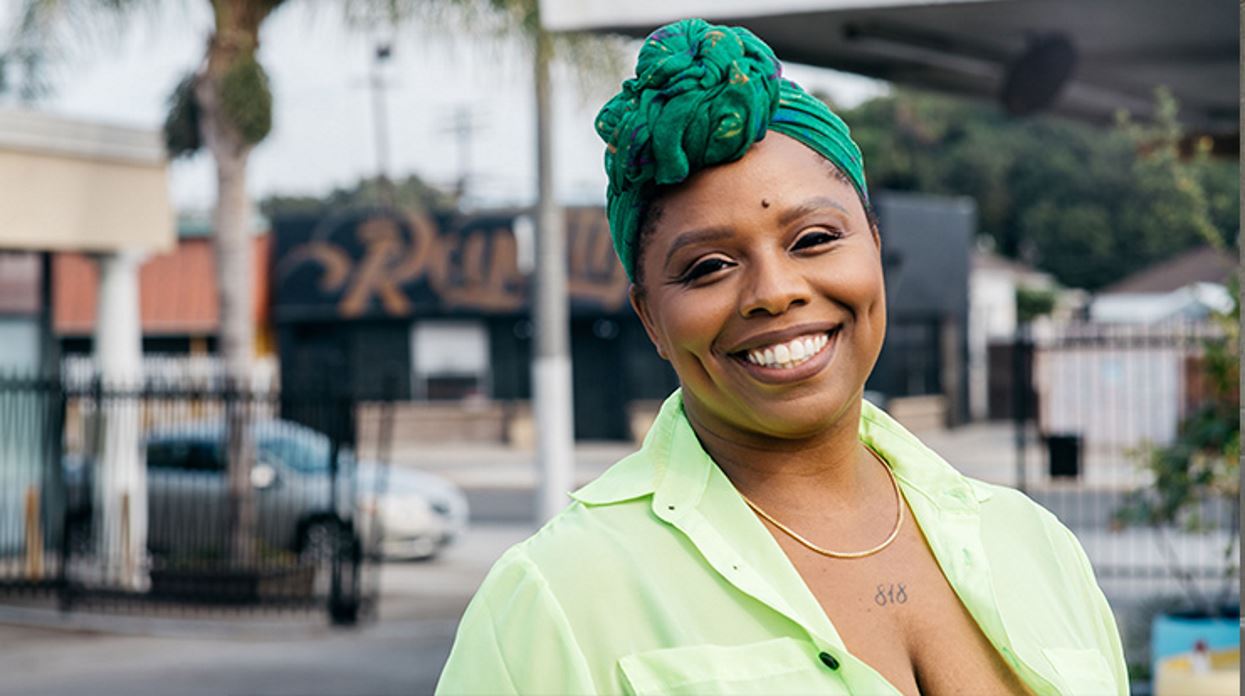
[1008, 320, 1240, 676]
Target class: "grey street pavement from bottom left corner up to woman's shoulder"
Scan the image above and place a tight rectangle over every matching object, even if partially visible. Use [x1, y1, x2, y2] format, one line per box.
[0, 525, 532, 696]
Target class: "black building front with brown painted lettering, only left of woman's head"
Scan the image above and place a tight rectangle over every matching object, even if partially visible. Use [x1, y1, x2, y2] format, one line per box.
[271, 208, 677, 440]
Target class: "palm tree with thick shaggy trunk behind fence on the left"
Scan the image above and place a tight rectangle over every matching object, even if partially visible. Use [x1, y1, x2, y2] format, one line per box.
[15, 0, 285, 560]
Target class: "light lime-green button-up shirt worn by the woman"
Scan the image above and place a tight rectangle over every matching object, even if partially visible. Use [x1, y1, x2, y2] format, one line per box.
[437, 391, 1128, 696]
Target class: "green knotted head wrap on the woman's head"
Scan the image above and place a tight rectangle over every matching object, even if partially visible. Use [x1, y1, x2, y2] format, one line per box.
[596, 19, 868, 280]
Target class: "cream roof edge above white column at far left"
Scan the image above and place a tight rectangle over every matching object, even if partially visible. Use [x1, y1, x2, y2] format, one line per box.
[0, 110, 176, 252]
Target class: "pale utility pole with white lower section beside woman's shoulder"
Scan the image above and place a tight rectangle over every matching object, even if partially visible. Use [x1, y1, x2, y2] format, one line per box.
[532, 29, 575, 524]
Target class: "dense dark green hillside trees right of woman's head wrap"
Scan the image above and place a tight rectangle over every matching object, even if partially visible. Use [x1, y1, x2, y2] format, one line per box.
[844, 90, 1240, 290]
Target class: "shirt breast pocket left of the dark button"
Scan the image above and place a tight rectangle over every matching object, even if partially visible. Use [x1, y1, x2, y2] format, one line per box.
[619, 637, 847, 696]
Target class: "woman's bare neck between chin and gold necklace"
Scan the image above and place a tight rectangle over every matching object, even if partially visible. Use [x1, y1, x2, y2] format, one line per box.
[685, 400, 890, 514]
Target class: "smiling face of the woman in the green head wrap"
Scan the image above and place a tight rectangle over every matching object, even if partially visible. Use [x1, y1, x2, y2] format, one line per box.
[631, 132, 886, 440]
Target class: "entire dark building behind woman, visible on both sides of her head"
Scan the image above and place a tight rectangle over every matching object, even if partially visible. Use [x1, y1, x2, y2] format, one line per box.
[270, 194, 974, 440]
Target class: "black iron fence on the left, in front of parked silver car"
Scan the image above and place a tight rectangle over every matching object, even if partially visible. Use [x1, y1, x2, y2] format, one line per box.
[0, 377, 388, 624]
